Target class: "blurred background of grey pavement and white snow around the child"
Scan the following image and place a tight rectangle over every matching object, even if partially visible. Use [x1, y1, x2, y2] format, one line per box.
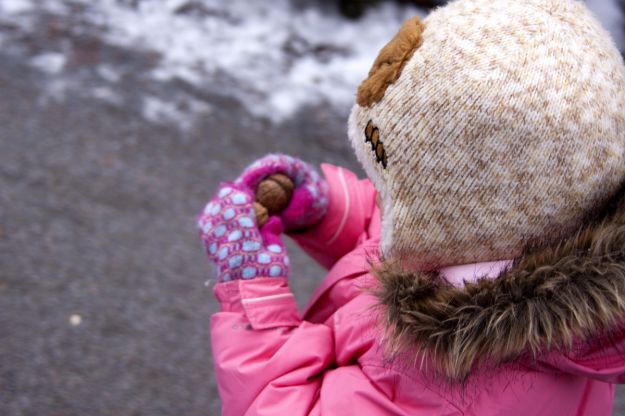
[0, 0, 625, 415]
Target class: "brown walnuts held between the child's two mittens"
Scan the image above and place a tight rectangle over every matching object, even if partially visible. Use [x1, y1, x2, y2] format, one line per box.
[254, 173, 295, 227]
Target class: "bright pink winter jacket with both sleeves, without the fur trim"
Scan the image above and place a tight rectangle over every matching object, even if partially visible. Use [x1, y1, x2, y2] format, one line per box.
[211, 165, 625, 416]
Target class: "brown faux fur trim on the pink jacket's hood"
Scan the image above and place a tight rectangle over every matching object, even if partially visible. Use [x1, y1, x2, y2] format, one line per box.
[374, 194, 625, 381]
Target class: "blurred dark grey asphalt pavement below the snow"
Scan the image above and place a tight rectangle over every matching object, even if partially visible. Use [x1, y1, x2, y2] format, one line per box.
[0, 8, 356, 416]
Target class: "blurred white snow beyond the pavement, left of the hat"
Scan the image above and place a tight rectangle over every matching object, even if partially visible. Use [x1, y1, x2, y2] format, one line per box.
[0, 0, 423, 122]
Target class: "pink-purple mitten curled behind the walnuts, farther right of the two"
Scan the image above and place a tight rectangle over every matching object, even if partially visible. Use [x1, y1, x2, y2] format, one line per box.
[236, 154, 329, 230]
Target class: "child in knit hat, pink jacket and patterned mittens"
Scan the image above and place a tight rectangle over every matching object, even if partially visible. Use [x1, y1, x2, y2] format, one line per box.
[199, 0, 625, 416]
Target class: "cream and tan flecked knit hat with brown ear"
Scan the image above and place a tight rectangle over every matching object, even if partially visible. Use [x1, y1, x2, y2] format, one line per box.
[349, 0, 625, 267]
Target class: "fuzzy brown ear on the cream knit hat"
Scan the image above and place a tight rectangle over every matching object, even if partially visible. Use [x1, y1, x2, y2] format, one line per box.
[356, 16, 425, 107]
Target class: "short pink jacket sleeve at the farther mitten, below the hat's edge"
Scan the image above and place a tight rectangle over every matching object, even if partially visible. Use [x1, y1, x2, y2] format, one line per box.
[289, 164, 376, 269]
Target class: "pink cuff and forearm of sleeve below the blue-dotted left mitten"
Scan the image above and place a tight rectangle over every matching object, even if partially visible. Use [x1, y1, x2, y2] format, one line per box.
[211, 278, 334, 416]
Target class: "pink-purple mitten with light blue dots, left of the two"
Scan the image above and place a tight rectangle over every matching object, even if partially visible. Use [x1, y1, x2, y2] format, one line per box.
[198, 183, 289, 282]
